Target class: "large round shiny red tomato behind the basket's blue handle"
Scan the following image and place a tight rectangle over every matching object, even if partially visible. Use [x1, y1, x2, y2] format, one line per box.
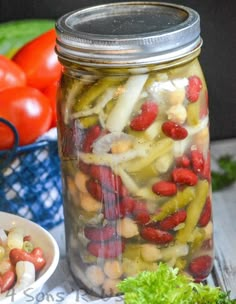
[0, 87, 52, 149]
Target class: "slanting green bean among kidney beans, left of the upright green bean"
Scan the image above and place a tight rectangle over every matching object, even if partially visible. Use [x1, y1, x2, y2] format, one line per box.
[151, 187, 195, 221]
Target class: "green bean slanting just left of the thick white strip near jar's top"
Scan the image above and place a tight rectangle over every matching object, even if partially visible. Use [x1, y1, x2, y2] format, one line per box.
[73, 77, 124, 112]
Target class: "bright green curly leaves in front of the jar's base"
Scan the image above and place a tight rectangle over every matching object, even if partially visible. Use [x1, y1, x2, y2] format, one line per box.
[118, 263, 236, 304]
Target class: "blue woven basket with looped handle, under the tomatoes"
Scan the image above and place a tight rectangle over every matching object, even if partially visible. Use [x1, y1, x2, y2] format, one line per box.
[0, 118, 63, 229]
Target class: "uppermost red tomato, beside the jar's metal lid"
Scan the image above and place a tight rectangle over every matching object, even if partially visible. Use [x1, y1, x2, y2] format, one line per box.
[13, 29, 61, 89]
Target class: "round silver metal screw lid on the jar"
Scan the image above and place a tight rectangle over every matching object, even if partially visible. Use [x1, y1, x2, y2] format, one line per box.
[56, 2, 201, 66]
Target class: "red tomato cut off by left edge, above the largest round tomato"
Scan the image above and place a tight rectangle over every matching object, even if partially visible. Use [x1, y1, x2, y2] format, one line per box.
[0, 55, 26, 91]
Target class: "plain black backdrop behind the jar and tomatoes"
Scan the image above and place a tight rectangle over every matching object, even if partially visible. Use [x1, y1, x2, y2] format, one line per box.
[0, 0, 236, 140]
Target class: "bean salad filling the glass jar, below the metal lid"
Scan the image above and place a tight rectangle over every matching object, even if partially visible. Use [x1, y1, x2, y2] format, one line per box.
[58, 59, 213, 296]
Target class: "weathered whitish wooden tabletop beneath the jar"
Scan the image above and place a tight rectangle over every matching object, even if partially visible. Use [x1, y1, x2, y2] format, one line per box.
[46, 138, 236, 298]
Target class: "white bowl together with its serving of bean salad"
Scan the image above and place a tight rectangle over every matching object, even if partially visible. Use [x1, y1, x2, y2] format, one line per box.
[0, 212, 59, 304]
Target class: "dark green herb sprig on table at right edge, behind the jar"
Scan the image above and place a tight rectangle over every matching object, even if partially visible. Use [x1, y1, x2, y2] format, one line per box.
[211, 155, 236, 191]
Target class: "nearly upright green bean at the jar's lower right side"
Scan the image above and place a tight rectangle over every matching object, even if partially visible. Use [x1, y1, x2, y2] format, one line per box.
[176, 180, 209, 243]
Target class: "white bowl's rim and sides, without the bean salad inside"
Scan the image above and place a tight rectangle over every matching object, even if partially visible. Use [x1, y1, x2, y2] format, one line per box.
[0, 212, 59, 304]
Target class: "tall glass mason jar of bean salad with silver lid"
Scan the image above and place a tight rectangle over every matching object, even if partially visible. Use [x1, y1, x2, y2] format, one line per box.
[56, 2, 213, 296]
